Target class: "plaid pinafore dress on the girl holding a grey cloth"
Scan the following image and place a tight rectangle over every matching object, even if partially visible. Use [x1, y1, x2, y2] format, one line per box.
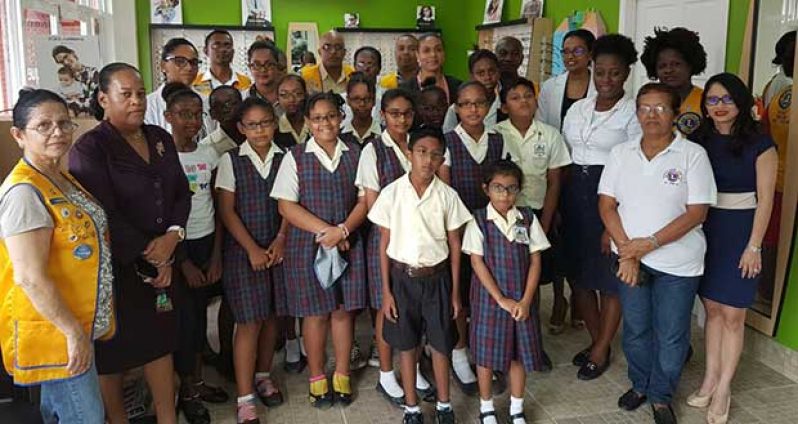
[284, 142, 368, 317]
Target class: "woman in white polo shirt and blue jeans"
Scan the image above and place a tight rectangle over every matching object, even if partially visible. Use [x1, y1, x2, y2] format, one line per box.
[598, 83, 717, 424]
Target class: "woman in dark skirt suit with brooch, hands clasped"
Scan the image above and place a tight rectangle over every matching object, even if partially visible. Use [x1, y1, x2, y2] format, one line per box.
[69, 63, 191, 424]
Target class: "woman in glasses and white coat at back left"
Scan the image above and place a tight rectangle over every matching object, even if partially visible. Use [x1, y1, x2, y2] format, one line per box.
[144, 38, 207, 135]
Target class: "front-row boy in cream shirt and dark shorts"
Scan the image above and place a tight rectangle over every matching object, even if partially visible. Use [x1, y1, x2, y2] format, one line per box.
[368, 128, 471, 424]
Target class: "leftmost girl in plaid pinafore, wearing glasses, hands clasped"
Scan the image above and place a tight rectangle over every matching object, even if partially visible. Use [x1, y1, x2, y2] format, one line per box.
[216, 97, 287, 423]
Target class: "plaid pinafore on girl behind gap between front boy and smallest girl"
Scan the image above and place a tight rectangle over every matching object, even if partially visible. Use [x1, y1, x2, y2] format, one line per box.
[444, 131, 504, 211]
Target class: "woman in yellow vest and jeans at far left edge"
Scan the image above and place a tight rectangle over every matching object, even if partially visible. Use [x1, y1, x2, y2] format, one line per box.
[0, 90, 115, 424]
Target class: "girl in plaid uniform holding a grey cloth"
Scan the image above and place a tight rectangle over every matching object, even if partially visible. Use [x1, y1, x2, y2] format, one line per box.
[271, 93, 368, 408]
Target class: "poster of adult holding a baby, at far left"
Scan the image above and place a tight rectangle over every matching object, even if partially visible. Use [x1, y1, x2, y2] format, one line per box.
[35, 35, 101, 117]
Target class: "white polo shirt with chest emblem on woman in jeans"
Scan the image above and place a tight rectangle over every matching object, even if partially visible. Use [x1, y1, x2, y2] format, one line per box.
[598, 132, 717, 277]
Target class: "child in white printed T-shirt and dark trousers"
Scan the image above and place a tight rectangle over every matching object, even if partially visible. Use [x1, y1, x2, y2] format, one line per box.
[162, 83, 228, 423]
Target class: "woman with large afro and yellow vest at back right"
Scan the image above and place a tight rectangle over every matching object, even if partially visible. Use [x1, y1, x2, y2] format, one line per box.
[640, 28, 707, 137]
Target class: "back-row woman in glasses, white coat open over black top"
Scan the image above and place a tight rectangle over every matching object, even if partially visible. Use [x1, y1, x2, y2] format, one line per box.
[535, 29, 596, 128]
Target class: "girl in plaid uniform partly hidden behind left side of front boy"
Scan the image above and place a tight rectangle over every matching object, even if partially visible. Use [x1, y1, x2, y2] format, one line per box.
[350, 88, 434, 406]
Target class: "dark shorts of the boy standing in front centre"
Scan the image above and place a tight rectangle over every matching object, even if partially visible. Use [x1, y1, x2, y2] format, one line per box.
[382, 261, 457, 356]
